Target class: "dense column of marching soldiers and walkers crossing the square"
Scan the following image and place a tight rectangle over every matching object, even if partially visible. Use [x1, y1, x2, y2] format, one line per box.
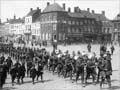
[0, 43, 114, 88]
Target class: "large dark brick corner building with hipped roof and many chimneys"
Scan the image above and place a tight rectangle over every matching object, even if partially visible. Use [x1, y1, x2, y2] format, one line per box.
[39, 2, 113, 42]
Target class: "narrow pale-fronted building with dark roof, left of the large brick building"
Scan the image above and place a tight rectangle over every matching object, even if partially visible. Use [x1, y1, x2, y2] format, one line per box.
[24, 7, 41, 43]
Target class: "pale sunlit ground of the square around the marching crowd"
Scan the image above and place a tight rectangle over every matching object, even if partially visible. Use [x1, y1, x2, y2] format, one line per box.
[3, 45, 120, 90]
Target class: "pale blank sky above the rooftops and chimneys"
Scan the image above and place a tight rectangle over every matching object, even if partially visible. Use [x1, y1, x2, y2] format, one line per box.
[0, 0, 120, 21]
